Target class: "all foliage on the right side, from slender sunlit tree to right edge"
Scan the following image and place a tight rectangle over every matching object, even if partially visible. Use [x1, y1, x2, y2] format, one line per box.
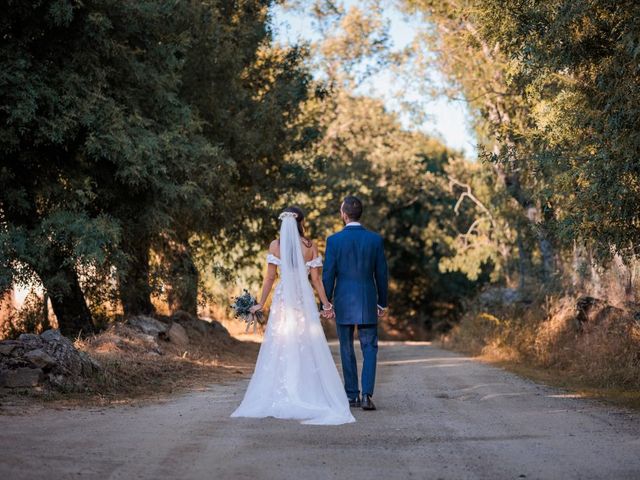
[404, 0, 640, 272]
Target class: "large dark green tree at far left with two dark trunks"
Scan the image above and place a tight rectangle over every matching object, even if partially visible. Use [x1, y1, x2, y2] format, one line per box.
[0, 0, 215, 334]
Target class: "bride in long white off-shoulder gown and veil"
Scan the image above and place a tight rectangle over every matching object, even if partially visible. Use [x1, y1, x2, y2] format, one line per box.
[231, 207, 355, 425]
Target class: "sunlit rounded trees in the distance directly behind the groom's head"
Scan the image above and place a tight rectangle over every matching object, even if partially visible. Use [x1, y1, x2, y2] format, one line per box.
[286, 91, 487, 328]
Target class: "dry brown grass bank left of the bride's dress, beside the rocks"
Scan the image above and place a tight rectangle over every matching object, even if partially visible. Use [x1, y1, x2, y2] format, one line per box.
[2, 322, 259, 406]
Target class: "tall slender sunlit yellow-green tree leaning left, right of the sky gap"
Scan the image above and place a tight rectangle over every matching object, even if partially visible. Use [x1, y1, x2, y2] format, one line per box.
[403, 0, 557, 286]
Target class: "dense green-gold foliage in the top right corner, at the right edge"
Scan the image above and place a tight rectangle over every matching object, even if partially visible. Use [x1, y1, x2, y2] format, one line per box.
[470, 0, 640, 258]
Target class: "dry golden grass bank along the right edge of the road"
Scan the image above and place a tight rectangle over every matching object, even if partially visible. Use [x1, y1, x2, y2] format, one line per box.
[442, 297, 640, 408]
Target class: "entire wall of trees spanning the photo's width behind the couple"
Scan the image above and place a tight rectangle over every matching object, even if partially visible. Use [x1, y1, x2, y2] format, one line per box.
[0, 0, 640, 335]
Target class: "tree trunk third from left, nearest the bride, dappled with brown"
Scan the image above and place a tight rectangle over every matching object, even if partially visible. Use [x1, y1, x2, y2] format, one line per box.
[165, 235, 199, 317]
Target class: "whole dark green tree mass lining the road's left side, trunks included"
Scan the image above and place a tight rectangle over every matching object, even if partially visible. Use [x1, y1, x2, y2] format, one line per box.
[0, 0, 312, 332]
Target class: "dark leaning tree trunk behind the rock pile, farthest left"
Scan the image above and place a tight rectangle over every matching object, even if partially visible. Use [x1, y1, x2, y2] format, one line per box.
[39, 256, 95, 338]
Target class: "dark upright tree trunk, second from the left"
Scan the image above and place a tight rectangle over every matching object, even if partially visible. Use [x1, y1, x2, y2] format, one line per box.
[119, 230, 155, 316]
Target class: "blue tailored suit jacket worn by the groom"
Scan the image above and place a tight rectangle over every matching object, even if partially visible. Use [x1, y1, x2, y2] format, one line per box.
[322, 225, 388, 325]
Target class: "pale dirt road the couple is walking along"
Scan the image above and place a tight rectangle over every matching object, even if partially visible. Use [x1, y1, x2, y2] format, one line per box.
[0, 343, 640, 480]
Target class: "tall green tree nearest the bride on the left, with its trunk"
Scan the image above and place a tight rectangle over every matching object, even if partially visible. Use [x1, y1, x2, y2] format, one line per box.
[165, 0, 314, 314]
